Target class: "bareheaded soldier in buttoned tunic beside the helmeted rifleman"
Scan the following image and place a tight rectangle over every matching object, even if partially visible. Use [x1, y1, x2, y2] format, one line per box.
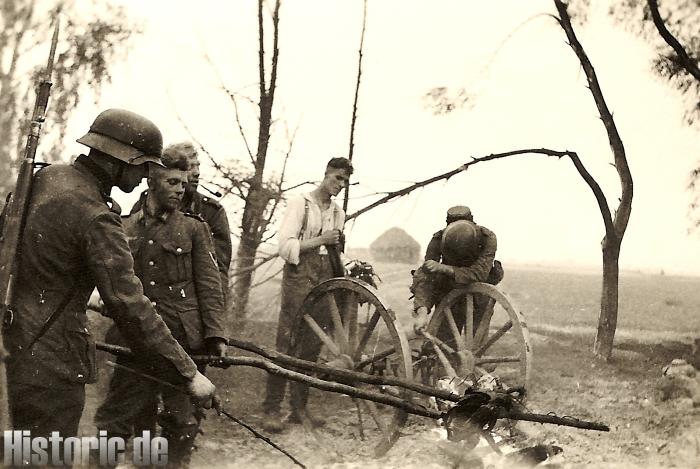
[95, 148, 227, 467]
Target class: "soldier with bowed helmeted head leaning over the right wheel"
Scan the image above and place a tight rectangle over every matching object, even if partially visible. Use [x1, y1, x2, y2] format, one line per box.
[411, 205, 503, 331]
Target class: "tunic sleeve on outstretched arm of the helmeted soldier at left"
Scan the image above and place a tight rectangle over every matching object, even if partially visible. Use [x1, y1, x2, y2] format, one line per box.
[85, 213, 197, 379]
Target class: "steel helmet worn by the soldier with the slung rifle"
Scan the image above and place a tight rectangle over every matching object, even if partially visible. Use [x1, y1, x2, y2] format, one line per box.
[77, 109, 163, 166]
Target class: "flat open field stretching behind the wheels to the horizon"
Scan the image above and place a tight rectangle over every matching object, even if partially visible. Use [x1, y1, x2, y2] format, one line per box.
[243, 259, 700, 341]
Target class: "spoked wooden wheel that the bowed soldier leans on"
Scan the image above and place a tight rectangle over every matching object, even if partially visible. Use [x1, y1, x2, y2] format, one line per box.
[415, 283, 532, 389]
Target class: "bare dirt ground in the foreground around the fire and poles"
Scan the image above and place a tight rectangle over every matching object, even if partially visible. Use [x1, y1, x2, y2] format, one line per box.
[84, 323, 700, 468]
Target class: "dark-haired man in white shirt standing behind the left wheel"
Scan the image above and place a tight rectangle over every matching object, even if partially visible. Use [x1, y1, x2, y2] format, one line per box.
[263, 158, 353, 432]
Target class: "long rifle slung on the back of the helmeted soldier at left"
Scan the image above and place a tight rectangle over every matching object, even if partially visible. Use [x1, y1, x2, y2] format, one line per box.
[0, 16, 59, 430]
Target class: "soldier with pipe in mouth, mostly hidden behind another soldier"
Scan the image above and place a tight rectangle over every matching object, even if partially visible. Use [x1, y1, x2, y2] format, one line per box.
[131, 142, 232, 296]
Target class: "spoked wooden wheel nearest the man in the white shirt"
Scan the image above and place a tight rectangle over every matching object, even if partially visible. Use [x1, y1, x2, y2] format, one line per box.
[292, 278, 413, 457]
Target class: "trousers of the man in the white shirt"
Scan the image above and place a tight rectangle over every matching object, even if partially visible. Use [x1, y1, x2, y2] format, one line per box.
[263, 252, 333, 413]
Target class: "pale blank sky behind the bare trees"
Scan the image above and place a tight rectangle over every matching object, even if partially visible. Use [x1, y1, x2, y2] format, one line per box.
[61, 0, 700, 275]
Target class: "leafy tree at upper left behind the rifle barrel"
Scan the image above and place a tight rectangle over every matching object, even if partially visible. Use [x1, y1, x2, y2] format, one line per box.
[0, 0, 136, 200]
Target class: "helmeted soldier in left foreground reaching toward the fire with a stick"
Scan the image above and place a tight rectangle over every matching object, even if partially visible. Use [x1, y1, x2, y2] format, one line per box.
[4, 109, 214, 460]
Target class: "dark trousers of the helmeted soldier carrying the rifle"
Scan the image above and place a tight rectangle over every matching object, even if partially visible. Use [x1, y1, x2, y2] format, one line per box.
[0, 380, 85, 467]
